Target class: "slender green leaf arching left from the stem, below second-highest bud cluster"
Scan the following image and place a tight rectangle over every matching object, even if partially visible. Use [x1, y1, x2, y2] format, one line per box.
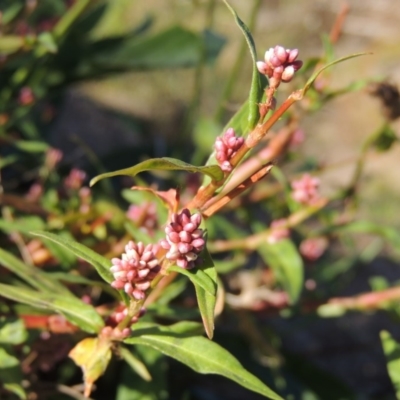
[90, 157, 224, 186]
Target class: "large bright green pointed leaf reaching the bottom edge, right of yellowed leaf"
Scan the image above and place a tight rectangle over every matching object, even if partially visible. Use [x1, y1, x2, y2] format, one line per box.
[124, 323, 282, 400]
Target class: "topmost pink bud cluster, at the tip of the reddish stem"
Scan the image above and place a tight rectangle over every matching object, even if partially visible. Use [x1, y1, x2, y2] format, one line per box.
[257, 46, 303, 89]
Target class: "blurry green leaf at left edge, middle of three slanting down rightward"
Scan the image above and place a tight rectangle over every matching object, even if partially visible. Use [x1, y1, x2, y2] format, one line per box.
[0, 249, 72, 296]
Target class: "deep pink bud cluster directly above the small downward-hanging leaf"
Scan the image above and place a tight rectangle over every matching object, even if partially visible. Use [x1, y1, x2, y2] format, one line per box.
[160, 209, 205, 269]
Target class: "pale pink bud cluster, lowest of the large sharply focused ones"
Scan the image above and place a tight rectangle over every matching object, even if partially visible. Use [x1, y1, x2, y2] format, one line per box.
[110, 241, 161, 300]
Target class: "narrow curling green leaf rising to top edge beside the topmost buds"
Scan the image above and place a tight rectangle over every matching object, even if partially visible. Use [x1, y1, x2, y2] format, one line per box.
[224, 0, 263, 128]
